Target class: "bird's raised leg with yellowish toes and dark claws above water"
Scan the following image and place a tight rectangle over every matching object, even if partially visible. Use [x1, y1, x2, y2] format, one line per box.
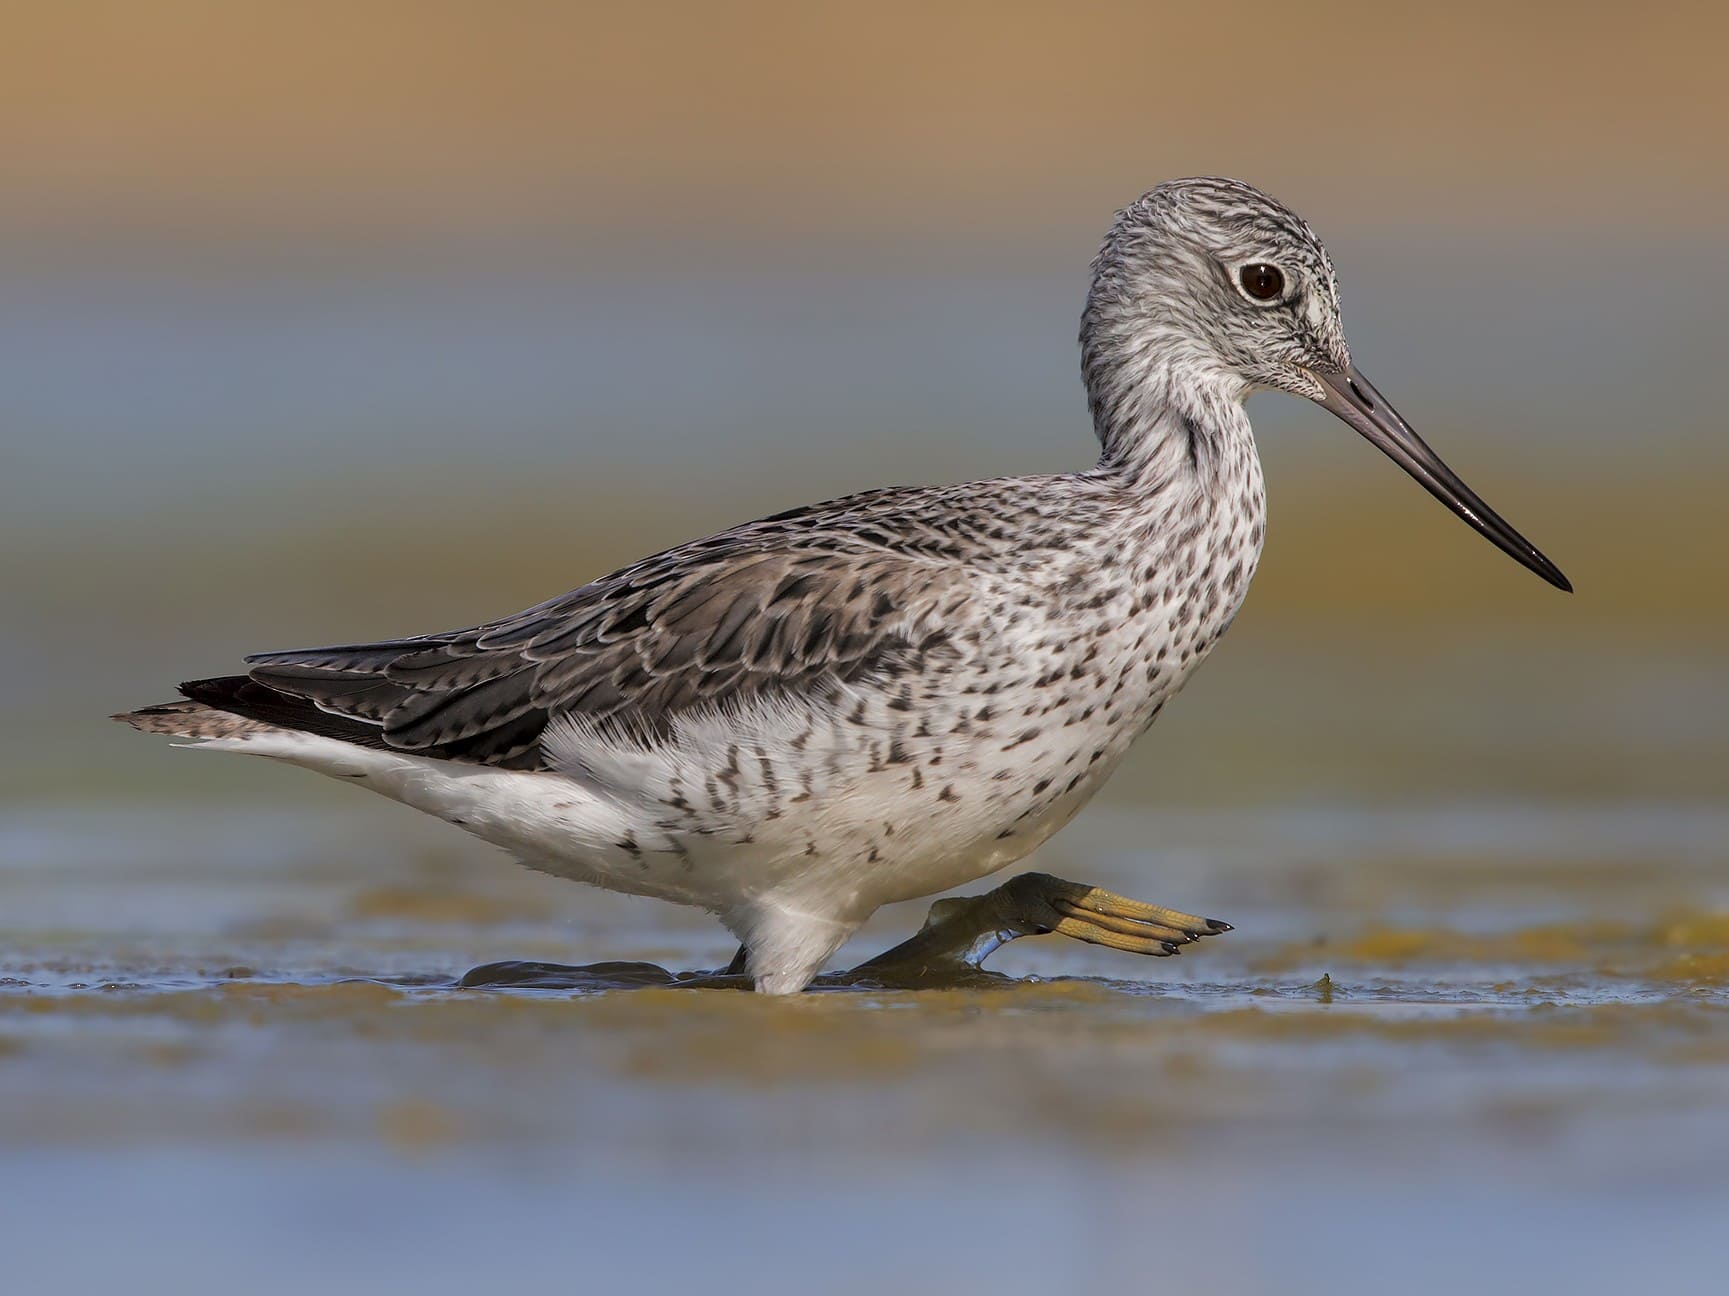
[845, 873, 1231, 987]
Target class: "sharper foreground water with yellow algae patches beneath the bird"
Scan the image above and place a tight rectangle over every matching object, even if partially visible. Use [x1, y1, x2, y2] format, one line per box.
[0, 798, 1729, 1293]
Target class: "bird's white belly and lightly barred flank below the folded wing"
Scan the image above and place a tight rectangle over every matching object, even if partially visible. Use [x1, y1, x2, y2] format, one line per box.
[189, 670, 1127, 923]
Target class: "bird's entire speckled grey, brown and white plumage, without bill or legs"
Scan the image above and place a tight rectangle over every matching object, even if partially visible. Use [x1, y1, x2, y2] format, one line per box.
[130, 180, 1528, 992]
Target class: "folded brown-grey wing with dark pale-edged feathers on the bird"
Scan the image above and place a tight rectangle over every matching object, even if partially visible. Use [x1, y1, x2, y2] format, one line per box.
[230, 501, 963, 769]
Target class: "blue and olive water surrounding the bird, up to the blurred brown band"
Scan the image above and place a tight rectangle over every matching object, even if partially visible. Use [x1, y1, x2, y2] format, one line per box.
[0, 245, 1729, 1296]
